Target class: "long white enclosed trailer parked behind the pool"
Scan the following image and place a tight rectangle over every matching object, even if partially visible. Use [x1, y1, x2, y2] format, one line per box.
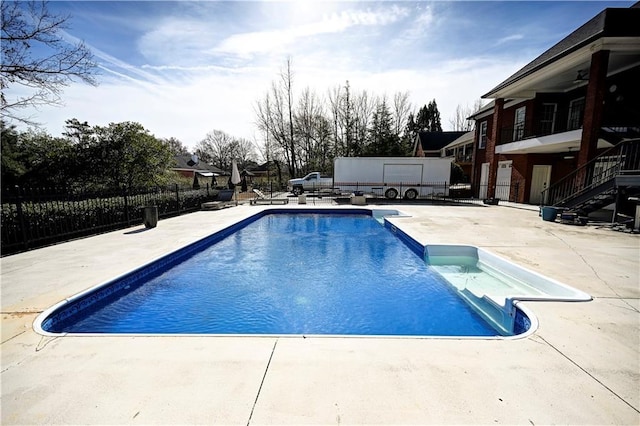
[333, 157, 453, 200]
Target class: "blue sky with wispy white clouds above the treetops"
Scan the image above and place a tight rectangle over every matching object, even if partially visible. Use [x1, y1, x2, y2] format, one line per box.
[11, 0, 633, 151]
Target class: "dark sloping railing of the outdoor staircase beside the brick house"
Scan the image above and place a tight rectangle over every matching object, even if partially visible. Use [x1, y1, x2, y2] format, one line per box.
[541, 138, 640, 206]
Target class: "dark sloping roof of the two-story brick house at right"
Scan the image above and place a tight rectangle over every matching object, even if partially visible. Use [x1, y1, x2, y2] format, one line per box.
[482, 2, 640, 98]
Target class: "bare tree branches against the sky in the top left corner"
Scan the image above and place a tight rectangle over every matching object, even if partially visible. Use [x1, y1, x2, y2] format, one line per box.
[0, 0, 97, 124]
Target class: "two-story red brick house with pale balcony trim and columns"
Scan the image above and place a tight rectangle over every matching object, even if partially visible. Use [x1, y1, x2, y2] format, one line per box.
[470, 3, 640, 218]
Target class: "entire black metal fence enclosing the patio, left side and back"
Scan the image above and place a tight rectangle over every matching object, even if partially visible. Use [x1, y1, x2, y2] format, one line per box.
[1, 182, 519, 256]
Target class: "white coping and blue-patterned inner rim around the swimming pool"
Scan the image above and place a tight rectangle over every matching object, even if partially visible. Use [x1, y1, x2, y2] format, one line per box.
[33, 207, 556, 340]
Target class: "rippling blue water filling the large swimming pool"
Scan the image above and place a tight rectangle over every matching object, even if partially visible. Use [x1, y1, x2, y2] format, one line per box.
[43, 213, 499, 336]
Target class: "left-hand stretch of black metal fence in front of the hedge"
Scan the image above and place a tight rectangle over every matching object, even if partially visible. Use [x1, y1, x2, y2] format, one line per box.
[1, 185, 218, 256]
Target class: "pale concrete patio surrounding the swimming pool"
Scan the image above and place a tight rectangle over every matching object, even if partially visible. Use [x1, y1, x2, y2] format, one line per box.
[0, 205, 640, 425]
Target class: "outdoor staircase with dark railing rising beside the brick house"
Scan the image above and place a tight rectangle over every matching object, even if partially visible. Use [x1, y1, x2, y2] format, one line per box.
[542, 138, 640, 221]
